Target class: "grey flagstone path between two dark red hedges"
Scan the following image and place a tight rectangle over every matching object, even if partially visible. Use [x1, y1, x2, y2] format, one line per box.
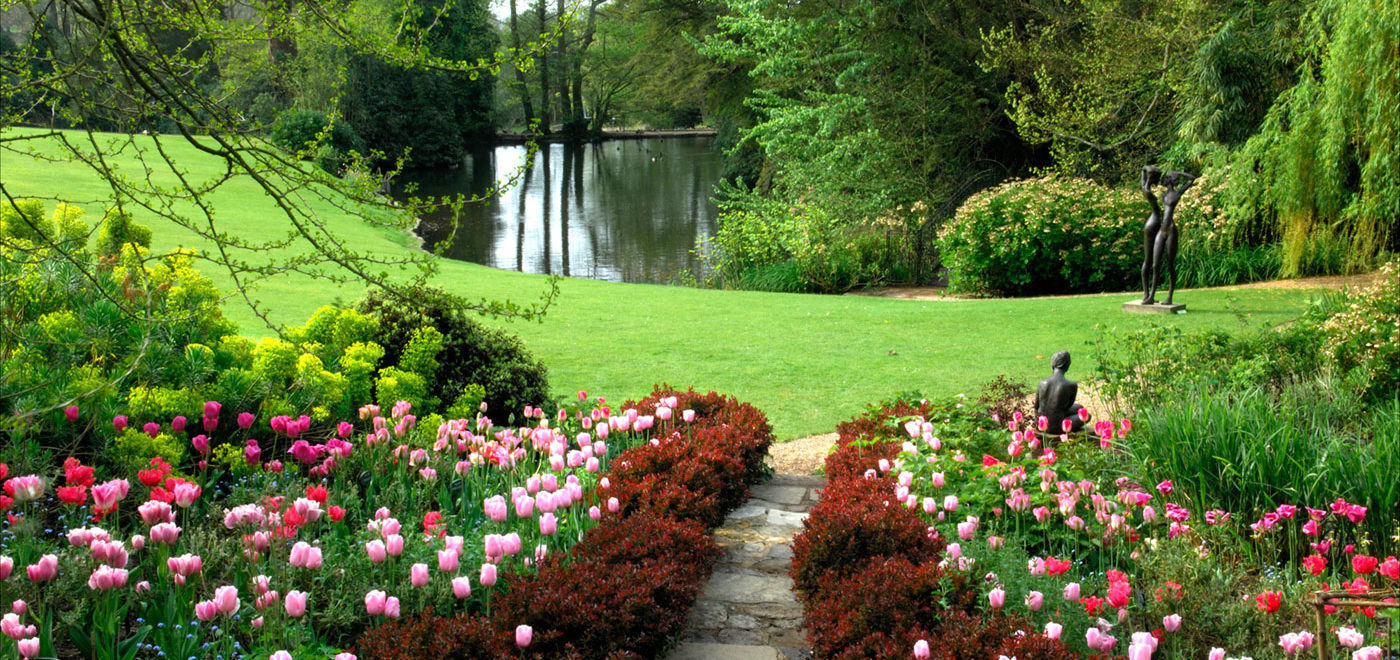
[666, 474, 826, 660]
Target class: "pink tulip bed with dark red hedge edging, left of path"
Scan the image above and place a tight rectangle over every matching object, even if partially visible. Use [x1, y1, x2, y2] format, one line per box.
[0, 390, 771, 660]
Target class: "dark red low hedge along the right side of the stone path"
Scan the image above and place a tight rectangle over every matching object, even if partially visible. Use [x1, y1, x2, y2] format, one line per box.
[790, 401, 1078, 660]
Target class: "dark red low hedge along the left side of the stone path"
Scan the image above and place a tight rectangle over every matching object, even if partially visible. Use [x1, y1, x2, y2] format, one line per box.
[347, 385, 773, 660]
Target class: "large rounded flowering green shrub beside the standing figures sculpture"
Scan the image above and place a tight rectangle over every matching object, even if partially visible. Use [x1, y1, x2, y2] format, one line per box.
[938, 177, 1147, 296]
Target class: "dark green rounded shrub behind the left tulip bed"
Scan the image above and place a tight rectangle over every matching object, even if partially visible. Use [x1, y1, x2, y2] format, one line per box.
[357, 287, 549, 420]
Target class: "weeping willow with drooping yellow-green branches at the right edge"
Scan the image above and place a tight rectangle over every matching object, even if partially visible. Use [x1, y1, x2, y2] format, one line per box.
[1233, 0, 1400, 275]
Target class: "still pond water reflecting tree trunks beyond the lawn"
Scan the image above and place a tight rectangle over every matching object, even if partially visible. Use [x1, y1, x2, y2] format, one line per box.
[406, 137, 720, 283]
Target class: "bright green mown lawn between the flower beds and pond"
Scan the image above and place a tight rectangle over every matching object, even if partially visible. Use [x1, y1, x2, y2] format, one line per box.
[0, 128, 1332, 439]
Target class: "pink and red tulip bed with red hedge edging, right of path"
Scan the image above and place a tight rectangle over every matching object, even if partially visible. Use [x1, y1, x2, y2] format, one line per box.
[791, 399, 1400, 660]
